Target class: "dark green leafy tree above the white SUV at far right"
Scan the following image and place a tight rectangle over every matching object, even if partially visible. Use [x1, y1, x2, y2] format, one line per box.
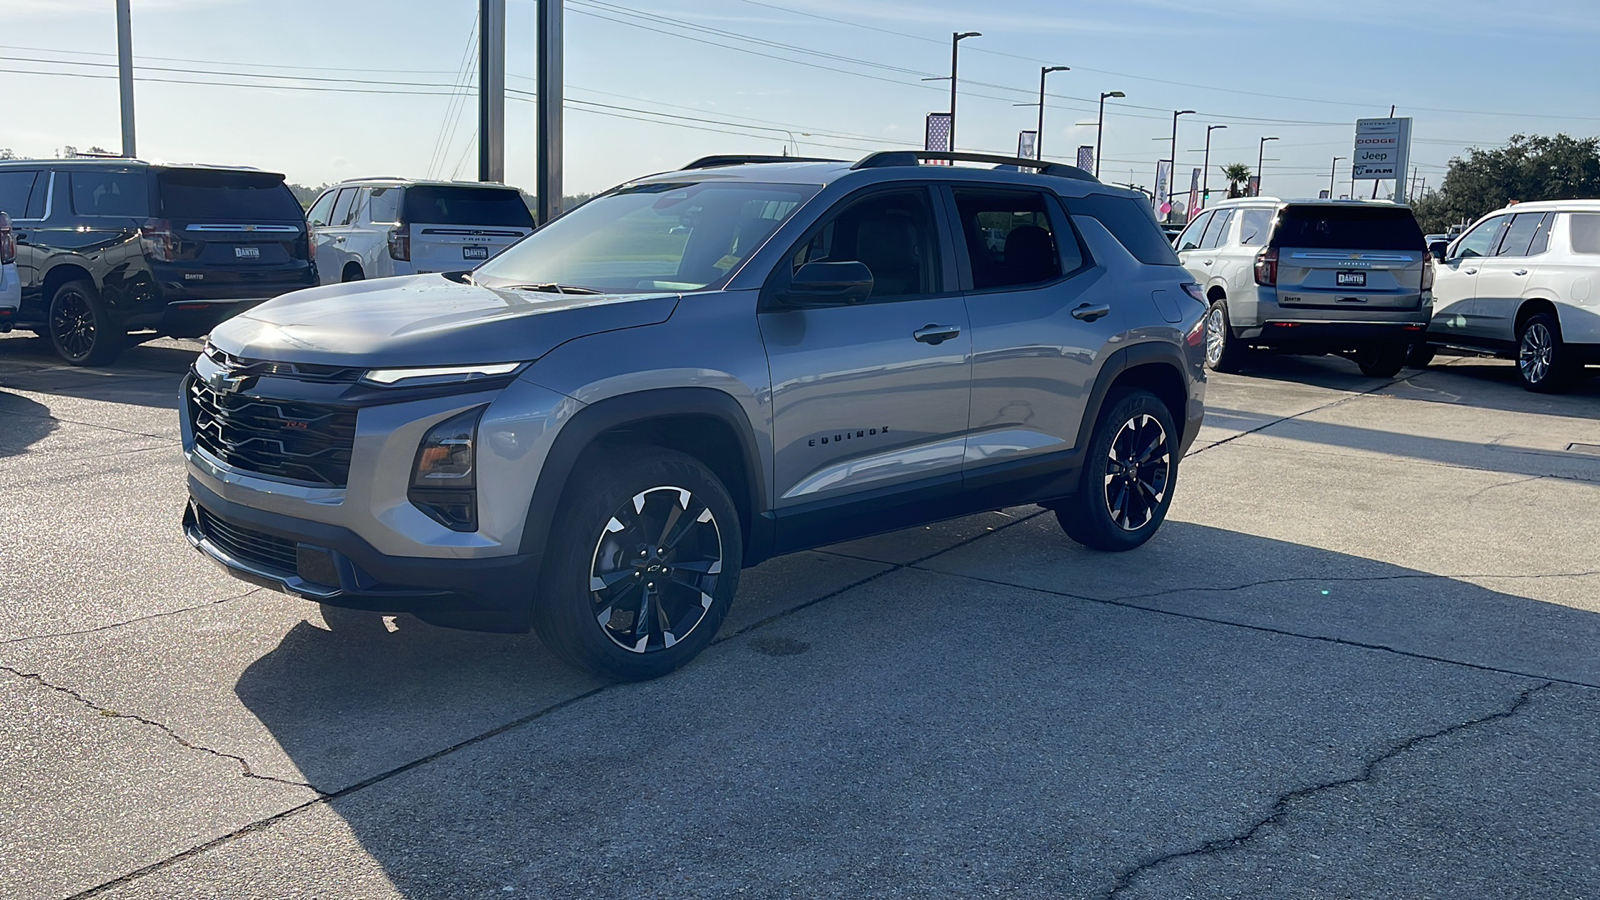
[1411, 135, 1600, 234]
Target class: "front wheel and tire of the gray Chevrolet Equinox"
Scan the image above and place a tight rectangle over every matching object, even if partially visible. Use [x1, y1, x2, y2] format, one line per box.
[533, 448, 742, 681]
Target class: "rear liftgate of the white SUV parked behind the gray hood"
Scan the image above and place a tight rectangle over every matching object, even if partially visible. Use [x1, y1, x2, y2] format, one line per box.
[402, 184, 533, 272]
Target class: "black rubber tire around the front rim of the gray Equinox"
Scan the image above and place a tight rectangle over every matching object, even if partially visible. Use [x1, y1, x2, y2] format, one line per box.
[533, 448, 742, 681]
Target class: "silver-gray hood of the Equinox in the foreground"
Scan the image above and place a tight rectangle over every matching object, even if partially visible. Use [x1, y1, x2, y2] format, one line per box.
[211, 275, 678, 368]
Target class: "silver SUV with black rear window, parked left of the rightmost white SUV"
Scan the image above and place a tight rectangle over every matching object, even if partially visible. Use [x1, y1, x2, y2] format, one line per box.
[1178, 197, 1434, 378]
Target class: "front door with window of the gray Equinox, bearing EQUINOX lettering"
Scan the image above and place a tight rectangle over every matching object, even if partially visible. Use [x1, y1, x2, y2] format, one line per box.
[760, 186, 973, 551]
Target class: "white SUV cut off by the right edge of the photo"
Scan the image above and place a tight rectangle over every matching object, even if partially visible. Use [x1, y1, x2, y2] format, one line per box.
[1413, 200, 1600, 392]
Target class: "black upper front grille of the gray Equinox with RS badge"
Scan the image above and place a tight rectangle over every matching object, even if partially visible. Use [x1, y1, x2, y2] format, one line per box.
[187, 378, 355, 487]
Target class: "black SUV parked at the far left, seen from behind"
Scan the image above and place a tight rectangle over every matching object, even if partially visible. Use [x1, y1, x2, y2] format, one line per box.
[0, 159, 317, 365]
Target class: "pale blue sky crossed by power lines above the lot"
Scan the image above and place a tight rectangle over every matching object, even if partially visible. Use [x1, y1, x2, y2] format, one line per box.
[0, 0, 1600, 197]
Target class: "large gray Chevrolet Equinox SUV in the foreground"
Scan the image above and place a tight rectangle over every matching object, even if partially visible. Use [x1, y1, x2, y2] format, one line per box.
[182, 152, 1205, 679]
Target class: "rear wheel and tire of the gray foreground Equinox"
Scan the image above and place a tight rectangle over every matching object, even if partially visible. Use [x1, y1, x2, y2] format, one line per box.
[1056, 389, 1178, 552]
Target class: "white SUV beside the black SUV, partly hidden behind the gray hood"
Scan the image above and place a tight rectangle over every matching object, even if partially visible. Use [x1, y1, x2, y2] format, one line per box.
[306, 178, 533, 283]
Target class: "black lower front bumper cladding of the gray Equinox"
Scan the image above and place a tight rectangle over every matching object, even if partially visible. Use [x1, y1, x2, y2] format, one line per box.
[186, 477, 539, 631]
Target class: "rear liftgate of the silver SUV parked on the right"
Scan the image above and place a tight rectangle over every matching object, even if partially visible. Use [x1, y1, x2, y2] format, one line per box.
[1270, 203, 1427, 311]
